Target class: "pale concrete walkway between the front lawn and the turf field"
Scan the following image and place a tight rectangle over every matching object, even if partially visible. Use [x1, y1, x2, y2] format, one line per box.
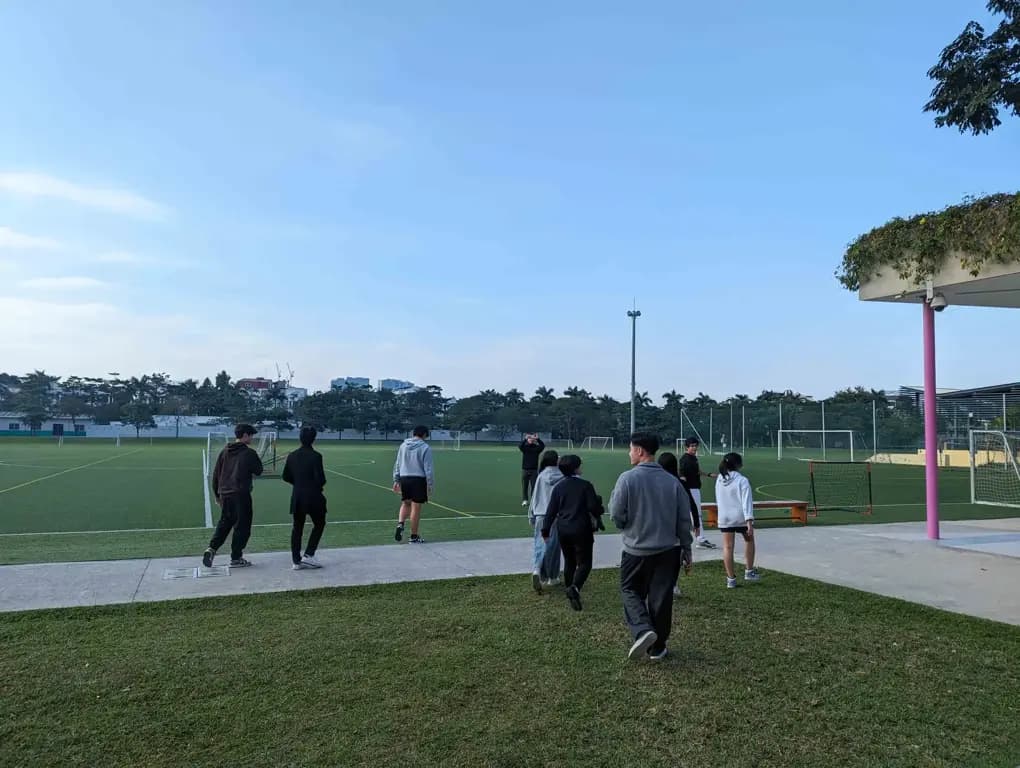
[0, 518, 1020, 625]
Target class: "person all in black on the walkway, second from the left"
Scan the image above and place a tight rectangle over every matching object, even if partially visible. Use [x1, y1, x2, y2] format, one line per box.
[284, 426, 325, 571]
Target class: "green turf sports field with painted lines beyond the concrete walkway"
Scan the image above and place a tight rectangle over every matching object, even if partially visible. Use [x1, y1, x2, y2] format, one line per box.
[0, 439, 1008, 563]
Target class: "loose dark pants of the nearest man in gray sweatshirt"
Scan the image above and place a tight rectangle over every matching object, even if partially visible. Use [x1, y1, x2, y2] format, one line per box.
[620, 547, 680, 652]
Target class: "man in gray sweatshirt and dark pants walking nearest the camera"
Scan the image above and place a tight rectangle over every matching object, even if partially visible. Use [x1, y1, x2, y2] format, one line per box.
[609, 432, 694, 661]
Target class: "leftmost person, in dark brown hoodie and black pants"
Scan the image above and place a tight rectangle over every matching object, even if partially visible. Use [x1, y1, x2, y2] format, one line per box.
[202, 424, 262, 568]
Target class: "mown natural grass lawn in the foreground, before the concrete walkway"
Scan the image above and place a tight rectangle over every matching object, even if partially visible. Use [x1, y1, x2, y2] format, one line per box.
[0, 564, 1020, 768]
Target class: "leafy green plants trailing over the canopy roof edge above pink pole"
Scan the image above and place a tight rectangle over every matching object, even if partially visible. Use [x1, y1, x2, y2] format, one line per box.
[835, 193, 1020, 291]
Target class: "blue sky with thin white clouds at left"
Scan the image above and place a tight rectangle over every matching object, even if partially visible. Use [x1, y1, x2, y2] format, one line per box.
[0, 0, 1020, 399]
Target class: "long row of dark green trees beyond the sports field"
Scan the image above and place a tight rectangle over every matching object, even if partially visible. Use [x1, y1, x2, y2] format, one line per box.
[0, 371, 938, 447]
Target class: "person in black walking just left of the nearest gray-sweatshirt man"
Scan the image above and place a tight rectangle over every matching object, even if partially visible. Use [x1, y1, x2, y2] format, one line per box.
[542, 454, 606, 611]
